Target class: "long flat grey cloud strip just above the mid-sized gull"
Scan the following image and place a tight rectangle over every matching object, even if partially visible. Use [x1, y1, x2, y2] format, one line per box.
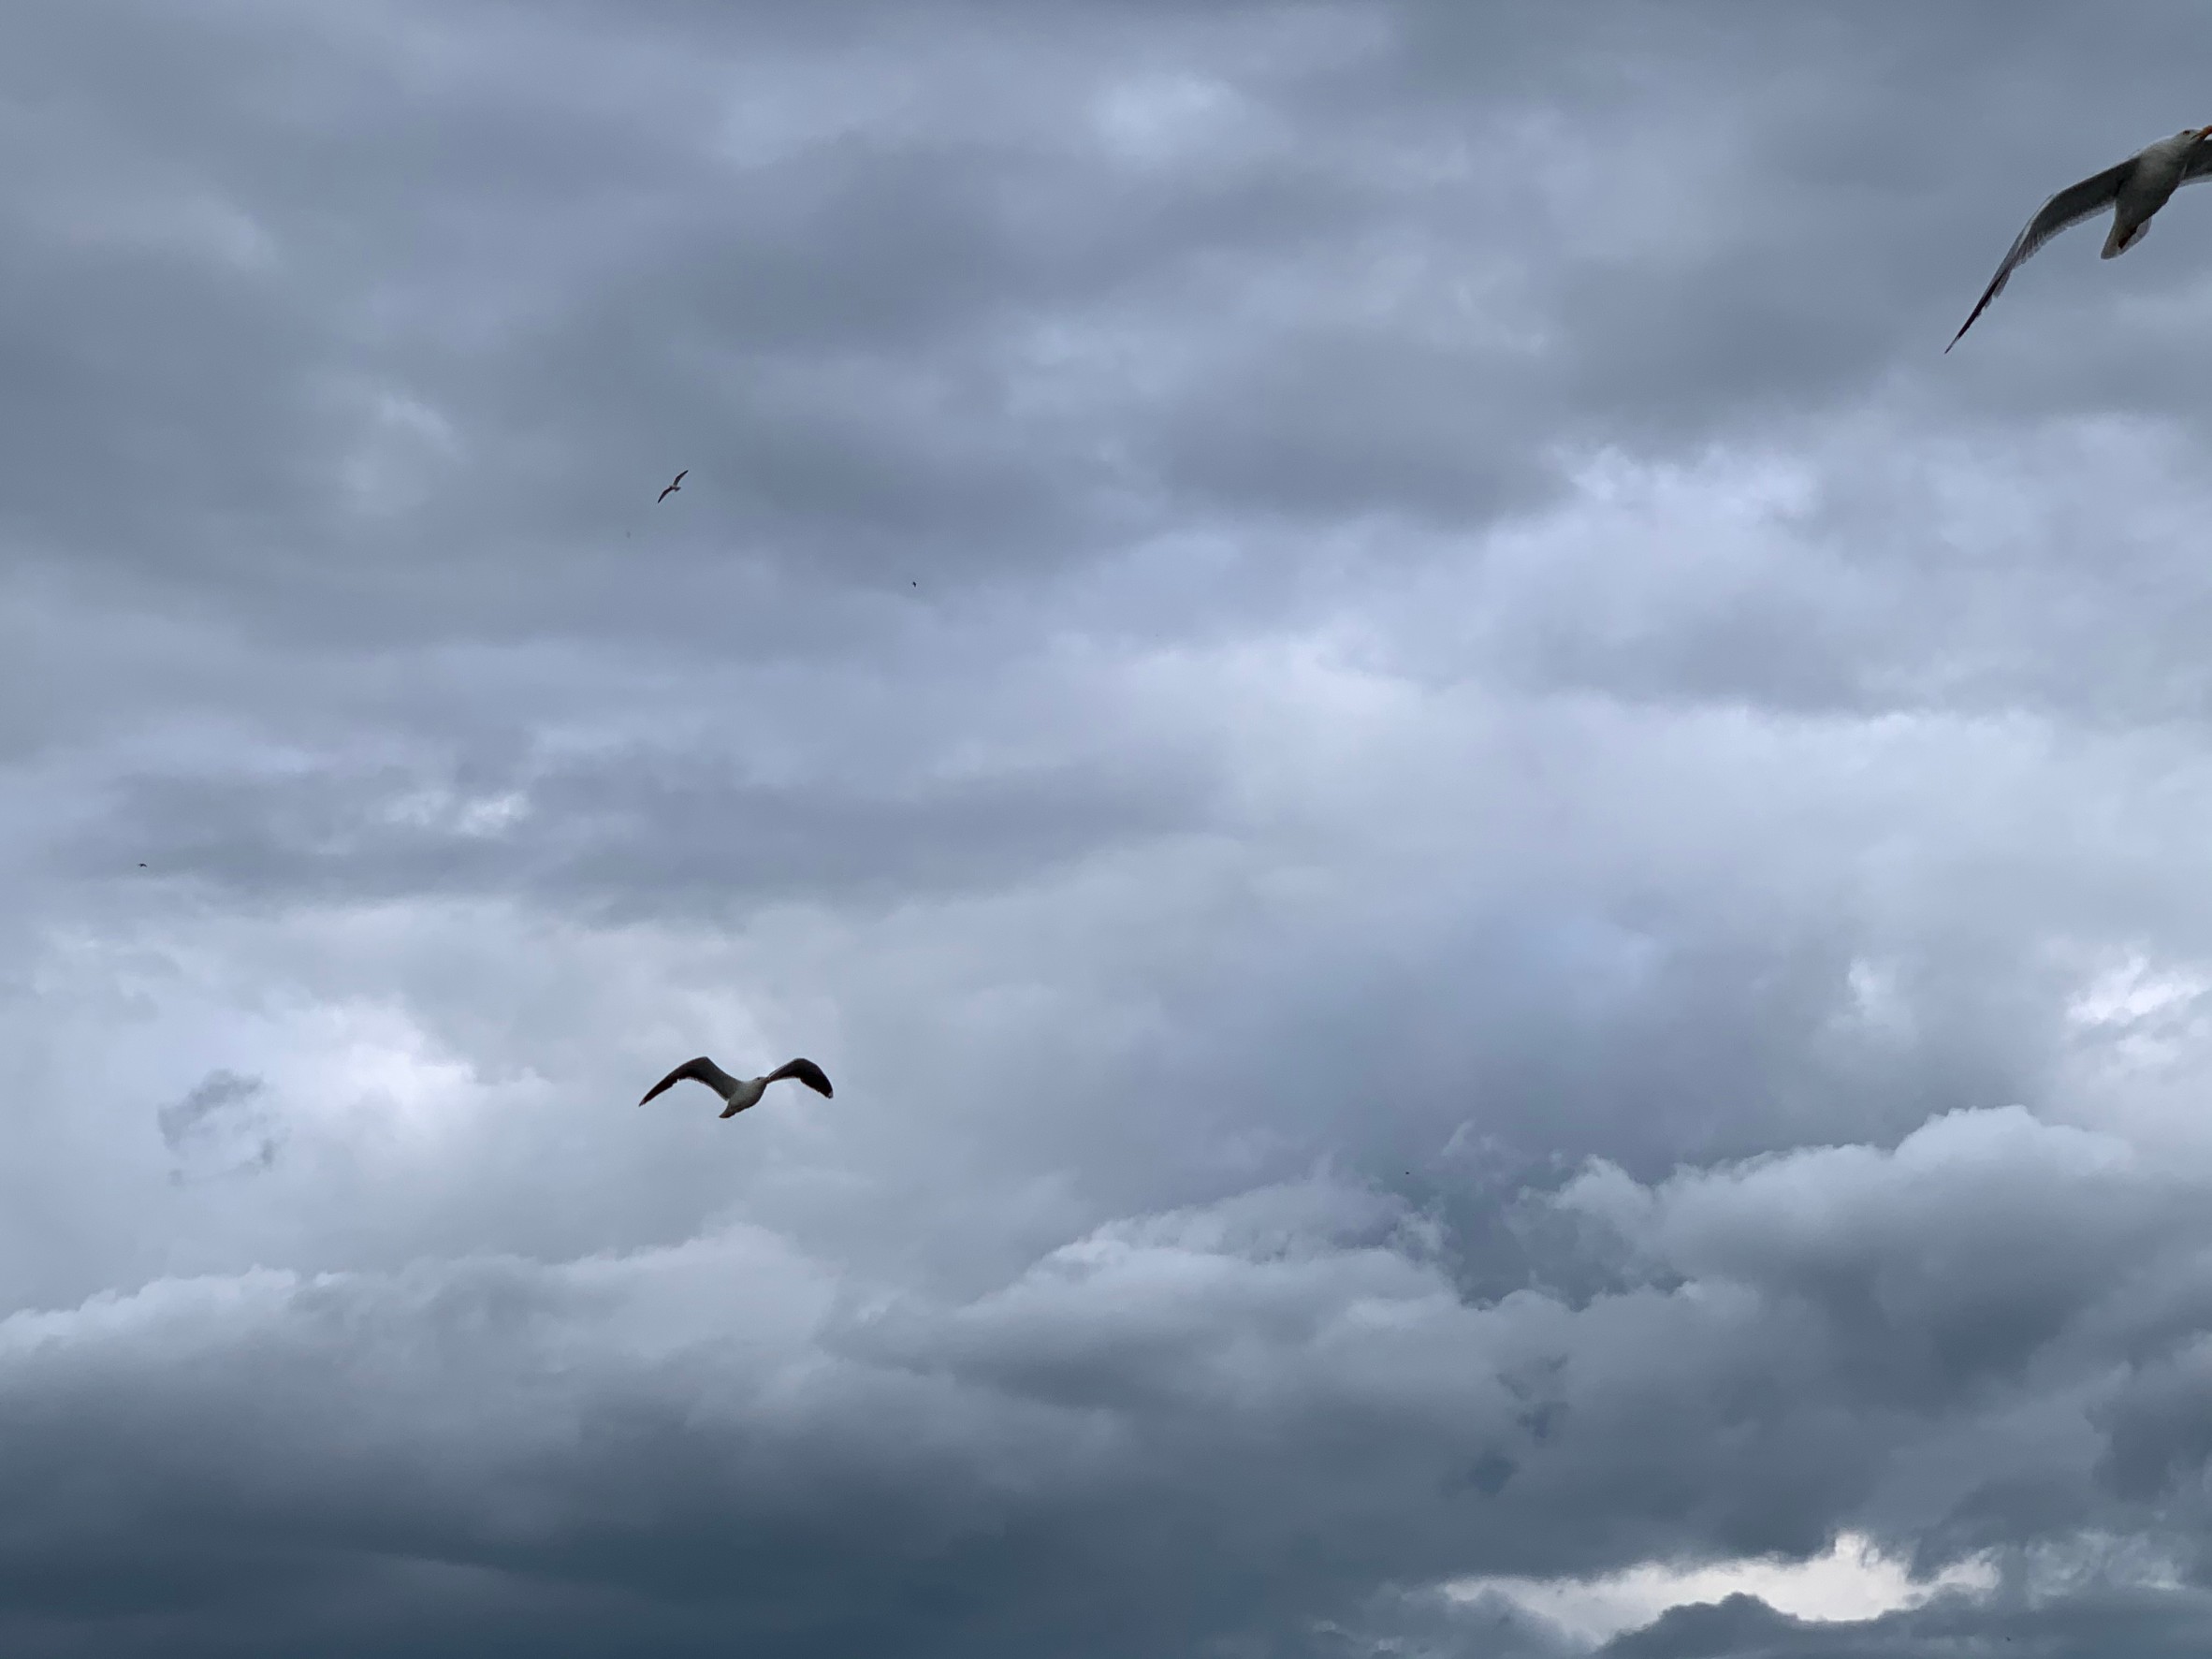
[80, 752, 1212, 913]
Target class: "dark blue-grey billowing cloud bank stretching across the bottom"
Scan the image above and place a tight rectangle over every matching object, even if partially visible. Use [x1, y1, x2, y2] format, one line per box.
[0, 1111, 2212, 1652]
